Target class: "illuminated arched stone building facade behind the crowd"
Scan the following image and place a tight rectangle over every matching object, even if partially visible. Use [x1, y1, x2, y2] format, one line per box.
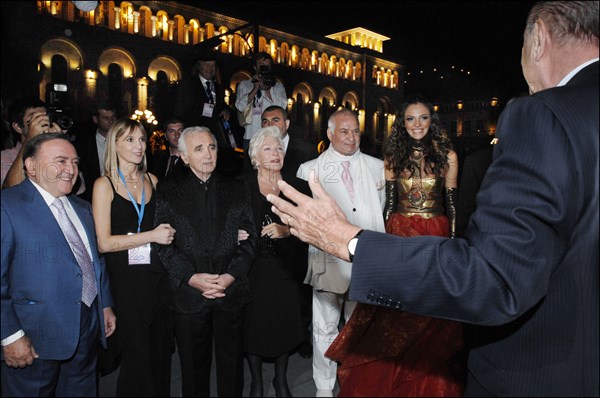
[2, 1, 404, 149]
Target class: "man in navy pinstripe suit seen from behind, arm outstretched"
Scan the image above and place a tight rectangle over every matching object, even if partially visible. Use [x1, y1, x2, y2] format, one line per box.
[268, 1, 600, 396]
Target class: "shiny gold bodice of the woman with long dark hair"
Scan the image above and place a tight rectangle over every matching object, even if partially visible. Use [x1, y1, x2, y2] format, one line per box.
[396, 176, 444, 218]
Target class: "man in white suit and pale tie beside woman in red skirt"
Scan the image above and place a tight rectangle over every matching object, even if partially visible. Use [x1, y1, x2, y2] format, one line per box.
[297, 109, 385, 397]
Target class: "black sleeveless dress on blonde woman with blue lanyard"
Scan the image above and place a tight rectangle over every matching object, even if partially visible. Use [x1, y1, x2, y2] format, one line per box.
[105, 176, 173, 396]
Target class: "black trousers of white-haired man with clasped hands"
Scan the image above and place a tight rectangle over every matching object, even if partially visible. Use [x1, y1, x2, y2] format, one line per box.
[175, 306, 244, 397]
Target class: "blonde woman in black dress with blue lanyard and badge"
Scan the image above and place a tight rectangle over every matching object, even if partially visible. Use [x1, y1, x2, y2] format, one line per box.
[92, 119, 175, 397]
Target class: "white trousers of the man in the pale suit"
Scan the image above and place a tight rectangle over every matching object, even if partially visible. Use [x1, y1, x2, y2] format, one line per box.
[312, 289, 356, 391]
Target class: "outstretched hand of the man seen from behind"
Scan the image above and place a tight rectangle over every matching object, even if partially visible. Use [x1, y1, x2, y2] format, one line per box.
[267, 170, 360, 261]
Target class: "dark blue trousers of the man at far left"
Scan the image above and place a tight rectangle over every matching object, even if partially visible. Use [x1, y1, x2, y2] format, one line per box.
[0, 302, 99, 397]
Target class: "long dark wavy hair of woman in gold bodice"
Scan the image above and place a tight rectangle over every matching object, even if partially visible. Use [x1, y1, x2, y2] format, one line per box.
[383, 96, 452, 178]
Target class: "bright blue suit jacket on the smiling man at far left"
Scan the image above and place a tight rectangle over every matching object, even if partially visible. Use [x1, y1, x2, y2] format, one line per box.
[1, 180, 113, 360]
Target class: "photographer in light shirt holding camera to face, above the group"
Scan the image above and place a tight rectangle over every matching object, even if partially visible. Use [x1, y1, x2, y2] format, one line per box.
[235, 51, 287, 153]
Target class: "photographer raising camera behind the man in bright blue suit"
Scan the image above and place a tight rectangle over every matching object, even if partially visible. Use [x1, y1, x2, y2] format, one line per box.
[0, 97, 64, 188]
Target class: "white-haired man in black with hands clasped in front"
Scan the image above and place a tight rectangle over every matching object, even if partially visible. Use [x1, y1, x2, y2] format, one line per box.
[156, 127, 257, 397]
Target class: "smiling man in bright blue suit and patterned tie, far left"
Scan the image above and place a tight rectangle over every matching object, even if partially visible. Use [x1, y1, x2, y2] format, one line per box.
[0, 133, 116, 397]
